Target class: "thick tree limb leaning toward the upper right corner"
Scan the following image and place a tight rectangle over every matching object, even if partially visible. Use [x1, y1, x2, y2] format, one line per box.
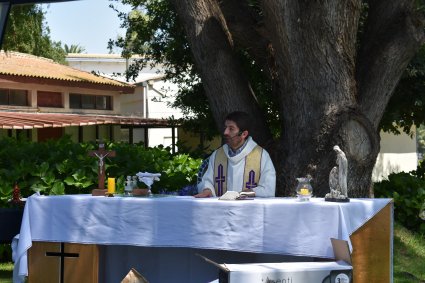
[356, 0, 425, 129]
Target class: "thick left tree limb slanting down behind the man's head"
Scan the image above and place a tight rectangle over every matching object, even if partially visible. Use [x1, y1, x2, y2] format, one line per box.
[167, 0, 271, 145]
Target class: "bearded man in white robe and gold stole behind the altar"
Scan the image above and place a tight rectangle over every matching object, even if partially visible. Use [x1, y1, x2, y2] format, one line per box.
[195, 111, 276, 198]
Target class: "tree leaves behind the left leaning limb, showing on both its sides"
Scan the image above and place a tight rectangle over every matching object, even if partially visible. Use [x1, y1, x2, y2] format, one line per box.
[108, 0, 281, 140]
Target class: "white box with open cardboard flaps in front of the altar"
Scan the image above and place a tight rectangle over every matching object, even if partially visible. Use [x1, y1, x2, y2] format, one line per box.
[201, 239, 353, 283]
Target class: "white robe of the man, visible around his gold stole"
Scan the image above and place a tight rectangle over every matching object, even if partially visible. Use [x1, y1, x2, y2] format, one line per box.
[198, 137, 276, 197]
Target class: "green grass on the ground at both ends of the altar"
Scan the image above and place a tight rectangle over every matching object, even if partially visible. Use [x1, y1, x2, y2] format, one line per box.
[0, 223, 425, 283]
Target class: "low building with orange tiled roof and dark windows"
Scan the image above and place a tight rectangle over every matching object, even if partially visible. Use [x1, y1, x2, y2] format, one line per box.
[0, 51, 176, 142]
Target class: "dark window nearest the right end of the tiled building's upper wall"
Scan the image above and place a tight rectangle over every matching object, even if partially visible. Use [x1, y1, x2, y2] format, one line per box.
[69, 93, 112, 110]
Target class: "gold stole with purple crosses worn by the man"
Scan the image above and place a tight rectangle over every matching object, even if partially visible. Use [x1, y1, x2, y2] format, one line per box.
[213, 145, 263, 196]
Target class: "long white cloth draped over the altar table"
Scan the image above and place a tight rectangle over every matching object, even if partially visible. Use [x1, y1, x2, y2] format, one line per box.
[14, 195, 391, 282]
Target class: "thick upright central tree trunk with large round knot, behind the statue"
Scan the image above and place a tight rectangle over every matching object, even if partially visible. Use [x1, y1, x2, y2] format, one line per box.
[263, 1, 379, 196]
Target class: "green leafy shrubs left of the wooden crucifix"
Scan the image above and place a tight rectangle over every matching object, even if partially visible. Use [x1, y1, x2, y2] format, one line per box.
[0, 137, 97, 202]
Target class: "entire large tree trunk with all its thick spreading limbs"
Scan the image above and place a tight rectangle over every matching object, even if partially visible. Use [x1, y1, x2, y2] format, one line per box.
[173, 0, 424, 197]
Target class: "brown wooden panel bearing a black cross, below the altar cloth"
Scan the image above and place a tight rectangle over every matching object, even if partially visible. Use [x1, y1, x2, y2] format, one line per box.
[28, 242, 99, 283]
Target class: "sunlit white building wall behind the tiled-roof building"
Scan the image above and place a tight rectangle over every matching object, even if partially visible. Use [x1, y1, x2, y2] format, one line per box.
[66, 54, 182, 150]
